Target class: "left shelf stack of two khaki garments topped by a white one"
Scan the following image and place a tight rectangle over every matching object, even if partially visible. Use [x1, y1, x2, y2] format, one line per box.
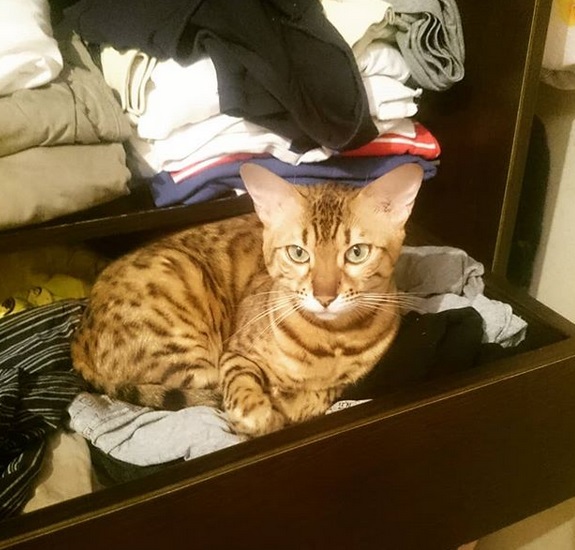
[0, 0, 131, 229]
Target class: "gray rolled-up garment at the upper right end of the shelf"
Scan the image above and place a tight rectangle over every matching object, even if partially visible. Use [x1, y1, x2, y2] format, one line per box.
[388, 0, 465, 91]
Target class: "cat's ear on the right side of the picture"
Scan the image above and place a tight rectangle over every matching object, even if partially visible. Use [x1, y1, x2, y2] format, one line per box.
[356, 163, 423, 226]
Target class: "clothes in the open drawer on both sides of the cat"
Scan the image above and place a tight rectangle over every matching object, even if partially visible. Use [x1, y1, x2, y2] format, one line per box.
[0, 246, 527, 519]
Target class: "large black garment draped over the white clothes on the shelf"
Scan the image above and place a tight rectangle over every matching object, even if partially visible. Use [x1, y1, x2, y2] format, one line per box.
[66, 0, 378, 151]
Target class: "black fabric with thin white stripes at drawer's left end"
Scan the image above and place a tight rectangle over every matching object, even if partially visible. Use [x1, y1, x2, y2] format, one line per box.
[0, 300, 85, 519]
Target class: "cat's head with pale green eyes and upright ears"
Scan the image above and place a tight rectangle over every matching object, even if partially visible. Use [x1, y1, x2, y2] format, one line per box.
[241, 164, 423, 321]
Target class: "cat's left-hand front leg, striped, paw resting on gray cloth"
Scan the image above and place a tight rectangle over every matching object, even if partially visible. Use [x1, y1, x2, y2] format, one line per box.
[220, 352, 286, 437]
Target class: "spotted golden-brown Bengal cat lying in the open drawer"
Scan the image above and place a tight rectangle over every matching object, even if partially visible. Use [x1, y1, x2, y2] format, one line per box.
[72, 164, 422, 436]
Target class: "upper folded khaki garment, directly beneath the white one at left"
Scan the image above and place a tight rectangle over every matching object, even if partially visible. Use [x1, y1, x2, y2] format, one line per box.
[0, 31, 131, 156]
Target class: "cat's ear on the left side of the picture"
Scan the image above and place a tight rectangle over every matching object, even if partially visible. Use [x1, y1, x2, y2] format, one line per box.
[240, 163, 303, 225]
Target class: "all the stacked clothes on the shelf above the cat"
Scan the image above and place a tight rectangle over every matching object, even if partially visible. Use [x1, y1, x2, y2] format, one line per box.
[0, 0, 465, 229]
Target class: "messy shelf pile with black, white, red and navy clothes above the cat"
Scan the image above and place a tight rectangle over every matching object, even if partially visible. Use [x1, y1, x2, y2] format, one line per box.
[66, 0, 464, 206]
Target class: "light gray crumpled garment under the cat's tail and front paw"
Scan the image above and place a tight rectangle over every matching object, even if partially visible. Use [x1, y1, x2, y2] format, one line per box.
[68, 392, 245, 466]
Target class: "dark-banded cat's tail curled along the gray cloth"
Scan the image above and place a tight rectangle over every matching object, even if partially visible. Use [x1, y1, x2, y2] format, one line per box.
[113, 384, 222, 411]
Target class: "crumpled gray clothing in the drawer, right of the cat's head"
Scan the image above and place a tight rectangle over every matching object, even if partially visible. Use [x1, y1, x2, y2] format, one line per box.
[395, 246, 527, 347]
